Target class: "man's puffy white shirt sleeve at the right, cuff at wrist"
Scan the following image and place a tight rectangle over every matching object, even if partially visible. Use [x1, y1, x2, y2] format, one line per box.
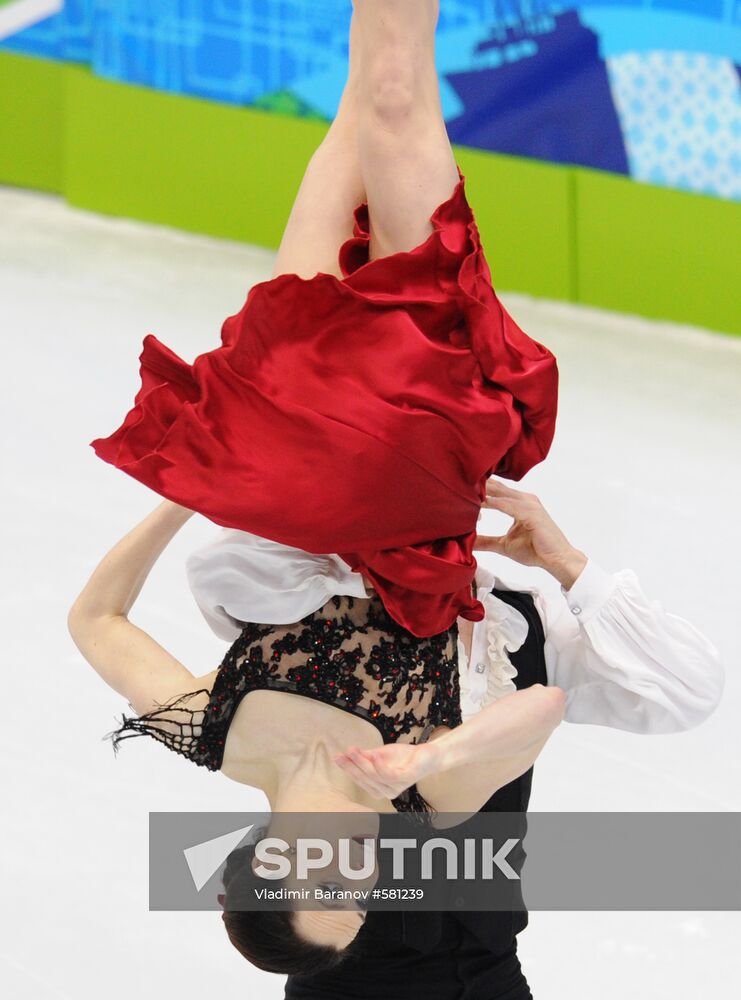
[534, 559, 725, 733]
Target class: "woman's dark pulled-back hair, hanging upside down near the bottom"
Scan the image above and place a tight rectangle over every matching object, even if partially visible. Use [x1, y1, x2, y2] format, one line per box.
[222, 829, 347, 976]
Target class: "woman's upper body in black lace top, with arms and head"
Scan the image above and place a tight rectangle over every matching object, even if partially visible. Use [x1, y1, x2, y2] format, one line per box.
[69, 500, 564, 974]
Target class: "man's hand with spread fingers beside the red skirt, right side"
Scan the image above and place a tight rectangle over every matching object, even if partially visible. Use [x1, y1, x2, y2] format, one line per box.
[474, 479, 587, 590]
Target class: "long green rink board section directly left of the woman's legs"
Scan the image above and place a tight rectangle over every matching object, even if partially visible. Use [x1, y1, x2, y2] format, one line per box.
[65, 67, 326, 248]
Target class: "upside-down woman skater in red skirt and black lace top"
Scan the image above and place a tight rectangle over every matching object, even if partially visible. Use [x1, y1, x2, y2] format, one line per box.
[69, 0, 563, 973]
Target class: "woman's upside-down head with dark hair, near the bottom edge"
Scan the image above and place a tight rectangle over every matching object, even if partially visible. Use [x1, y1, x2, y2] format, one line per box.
[223, 830, 364, 975]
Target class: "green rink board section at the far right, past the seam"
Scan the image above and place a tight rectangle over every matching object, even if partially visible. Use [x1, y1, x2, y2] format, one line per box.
[575, 169, 741, 334]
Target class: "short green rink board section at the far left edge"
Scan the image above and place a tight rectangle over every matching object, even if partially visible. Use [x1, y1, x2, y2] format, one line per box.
[0, 52, 65, 193]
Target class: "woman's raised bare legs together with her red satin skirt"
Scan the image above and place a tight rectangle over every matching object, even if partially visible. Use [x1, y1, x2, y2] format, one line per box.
[85, 0, 558, 637]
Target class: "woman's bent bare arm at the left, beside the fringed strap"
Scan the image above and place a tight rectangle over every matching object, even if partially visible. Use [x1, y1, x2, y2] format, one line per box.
[67, 500, 205, 715]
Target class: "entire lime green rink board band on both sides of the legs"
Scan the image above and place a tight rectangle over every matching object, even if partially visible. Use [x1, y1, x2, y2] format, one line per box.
[0, 51, 741, 333]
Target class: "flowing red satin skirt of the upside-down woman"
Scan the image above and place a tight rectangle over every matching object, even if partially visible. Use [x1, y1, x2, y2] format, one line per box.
[92, 163, 558, 636]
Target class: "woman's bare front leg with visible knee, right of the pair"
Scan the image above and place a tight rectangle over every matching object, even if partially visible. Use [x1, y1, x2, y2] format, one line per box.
[353, 0, 458, 258]
